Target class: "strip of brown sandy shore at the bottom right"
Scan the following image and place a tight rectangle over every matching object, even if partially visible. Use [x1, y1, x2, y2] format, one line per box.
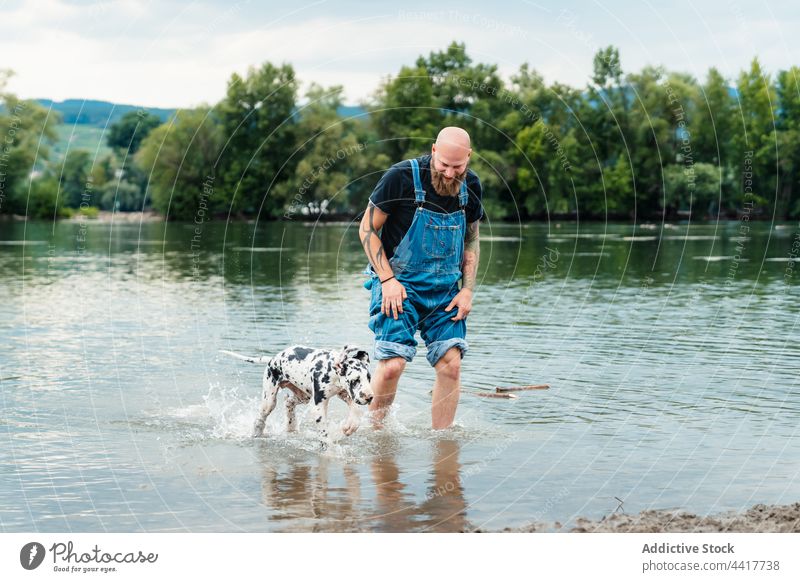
[488, 503, 800, 533]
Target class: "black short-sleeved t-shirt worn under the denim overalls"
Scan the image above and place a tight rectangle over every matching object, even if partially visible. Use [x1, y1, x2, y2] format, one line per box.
[369, 154, 483, 259]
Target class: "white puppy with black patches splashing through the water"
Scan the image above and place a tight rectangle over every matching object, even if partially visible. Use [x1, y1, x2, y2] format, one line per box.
[220, 345, 372, 438]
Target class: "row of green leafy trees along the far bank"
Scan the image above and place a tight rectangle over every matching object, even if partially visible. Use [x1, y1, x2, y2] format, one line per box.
[0, 43, 800, 220]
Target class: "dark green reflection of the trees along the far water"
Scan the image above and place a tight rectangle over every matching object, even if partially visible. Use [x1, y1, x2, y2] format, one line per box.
[0, 222, 797, 289]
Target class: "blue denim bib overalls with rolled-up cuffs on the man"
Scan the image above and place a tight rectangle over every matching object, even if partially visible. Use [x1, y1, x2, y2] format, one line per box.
[364, 159, 467, 366]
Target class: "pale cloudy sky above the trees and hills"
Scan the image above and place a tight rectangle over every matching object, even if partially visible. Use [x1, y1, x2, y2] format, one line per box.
[0, 0, 800, 108]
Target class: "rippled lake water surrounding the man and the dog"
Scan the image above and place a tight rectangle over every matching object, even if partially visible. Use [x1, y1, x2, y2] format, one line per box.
[0, 221, 800, 532]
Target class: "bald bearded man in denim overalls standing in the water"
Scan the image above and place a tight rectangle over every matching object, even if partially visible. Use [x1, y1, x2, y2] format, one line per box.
[359, 127, 483, 429]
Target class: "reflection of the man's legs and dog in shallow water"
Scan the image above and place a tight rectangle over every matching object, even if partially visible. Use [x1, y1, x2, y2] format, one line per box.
[253, 432, 472, 532]
